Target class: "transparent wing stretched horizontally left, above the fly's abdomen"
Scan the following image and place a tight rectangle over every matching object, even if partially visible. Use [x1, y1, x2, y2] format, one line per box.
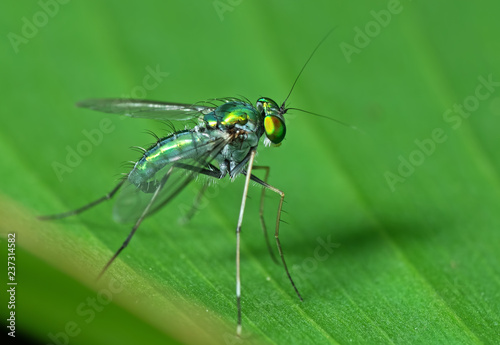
[76, 98, 215, 121]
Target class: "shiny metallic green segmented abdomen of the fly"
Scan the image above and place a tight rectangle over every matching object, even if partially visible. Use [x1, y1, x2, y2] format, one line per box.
[128, 130, 220, 188]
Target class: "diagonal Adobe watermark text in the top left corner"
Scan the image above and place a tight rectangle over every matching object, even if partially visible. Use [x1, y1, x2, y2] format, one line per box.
[7, 0, 70, 54]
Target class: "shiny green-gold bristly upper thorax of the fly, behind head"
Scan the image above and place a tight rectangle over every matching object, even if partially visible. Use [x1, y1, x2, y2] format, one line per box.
[203, 101, 262, 138]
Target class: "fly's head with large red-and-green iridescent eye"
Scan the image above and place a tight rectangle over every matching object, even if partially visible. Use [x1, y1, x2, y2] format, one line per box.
[256, 97, 287, 146]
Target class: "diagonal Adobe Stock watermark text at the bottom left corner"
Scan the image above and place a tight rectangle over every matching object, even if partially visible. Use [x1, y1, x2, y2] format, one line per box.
[47, 280, 123, 345]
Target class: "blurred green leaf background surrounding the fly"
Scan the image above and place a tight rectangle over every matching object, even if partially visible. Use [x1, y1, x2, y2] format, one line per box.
[0, 0, 500, 344]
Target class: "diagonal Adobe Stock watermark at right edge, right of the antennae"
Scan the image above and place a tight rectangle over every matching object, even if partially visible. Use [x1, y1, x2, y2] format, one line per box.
[384, 74, 500, 192]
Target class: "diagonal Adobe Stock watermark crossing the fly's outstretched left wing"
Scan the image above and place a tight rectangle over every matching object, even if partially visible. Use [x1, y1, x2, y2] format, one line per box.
[51, 65, 169, 182]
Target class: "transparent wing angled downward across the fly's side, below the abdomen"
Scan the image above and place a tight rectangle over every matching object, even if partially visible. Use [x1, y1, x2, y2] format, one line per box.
[113, 132, 229, 223]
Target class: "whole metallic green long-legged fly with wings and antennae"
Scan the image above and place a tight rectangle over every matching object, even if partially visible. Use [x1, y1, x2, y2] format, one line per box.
[40, 28, 348, 335]
